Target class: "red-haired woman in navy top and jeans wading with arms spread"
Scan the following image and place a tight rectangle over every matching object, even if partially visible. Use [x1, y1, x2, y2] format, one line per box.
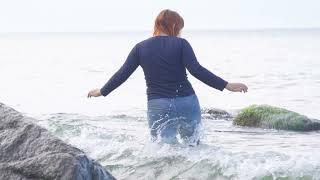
[88, 10, 248, 145]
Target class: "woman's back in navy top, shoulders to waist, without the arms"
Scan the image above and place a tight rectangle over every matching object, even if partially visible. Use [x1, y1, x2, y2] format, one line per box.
[138, 36, 194, 99]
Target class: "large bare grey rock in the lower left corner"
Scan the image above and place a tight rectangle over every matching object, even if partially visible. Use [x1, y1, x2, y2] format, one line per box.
[0, 103, 115, 180]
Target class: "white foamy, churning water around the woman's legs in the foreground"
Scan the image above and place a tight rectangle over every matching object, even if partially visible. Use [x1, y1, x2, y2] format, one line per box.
[33, 114, 320, 179]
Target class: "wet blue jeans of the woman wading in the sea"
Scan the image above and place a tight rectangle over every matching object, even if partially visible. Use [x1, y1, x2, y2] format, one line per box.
[148, 94, 201, 144]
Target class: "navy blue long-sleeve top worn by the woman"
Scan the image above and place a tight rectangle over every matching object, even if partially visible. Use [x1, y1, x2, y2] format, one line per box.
[100, 36, 228, 100]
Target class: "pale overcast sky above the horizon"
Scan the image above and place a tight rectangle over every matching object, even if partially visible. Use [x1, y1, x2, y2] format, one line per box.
[0, 0, 320, 32]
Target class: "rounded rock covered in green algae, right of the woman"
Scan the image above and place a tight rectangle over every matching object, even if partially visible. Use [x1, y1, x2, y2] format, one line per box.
[233, 105, 320, 131]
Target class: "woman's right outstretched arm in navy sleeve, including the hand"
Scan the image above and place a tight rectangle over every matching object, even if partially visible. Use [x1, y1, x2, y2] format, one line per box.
[182, 39, 248, 92]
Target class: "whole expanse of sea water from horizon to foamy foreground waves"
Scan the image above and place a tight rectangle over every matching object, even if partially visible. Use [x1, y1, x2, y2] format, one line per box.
[0, 29, 320, 179]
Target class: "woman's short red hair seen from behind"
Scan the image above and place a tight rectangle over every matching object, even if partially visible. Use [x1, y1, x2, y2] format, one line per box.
[153, 9, 184, 36]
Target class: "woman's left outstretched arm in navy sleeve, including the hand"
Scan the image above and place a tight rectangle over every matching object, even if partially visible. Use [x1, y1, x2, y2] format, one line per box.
[88, 45, 139, 97]
